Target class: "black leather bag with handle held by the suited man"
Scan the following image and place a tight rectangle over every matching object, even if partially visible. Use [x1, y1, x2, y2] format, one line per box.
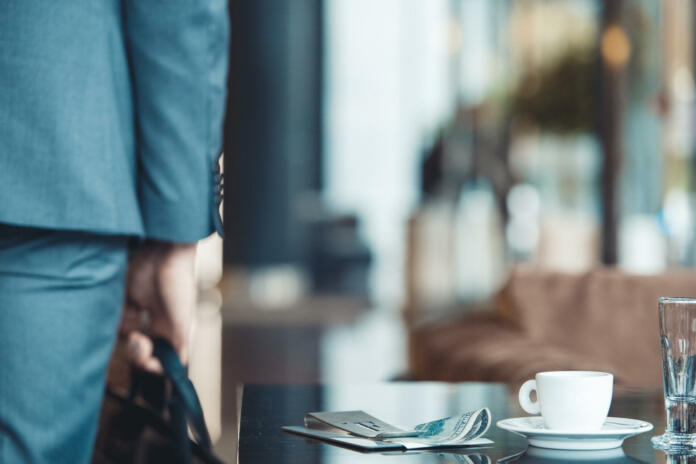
[92, 338, 223, 464]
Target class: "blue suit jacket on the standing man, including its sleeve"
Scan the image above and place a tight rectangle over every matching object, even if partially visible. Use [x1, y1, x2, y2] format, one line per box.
[0, 0, 228, 241]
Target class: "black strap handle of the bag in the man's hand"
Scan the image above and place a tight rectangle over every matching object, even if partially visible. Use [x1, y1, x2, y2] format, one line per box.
[152, 337, 222, 464]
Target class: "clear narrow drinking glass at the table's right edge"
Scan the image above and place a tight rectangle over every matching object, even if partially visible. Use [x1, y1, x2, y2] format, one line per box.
[651, 298, 696, 452]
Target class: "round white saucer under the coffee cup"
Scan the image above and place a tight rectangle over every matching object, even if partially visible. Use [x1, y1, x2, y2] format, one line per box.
[496, 416, 652, 450]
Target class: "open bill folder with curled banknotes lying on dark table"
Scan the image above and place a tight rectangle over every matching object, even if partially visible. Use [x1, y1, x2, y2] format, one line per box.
[283, 408, 493, 451]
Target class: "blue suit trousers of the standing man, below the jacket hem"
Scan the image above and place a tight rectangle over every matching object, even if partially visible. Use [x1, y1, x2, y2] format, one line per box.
[0, 225, 128, 463]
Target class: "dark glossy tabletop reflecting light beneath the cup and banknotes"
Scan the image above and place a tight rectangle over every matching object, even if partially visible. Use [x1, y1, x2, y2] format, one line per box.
[238, 382, 696, 464]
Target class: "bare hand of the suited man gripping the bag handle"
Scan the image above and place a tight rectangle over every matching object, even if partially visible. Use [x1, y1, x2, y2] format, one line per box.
[120, 241, 196, 373]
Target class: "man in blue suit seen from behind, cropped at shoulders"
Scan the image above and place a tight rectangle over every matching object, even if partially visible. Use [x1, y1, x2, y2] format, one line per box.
[0, 0, 228, 463]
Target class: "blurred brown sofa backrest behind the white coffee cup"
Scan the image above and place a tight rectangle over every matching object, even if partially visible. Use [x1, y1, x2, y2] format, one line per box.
[498, 268, 696, 385]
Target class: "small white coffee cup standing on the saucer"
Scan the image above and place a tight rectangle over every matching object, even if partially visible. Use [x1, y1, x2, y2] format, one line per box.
[519, 371, 614, 432]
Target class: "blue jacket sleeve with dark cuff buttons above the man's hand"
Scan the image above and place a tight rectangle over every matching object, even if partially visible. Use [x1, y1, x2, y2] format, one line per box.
[123, 0, 229, 242]
